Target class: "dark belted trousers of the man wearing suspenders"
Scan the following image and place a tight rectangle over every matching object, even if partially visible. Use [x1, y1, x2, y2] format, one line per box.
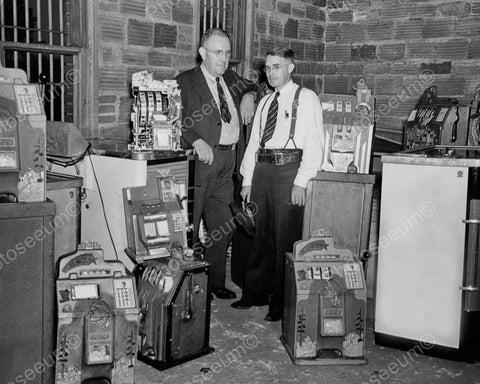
[242, 163, 303, 311]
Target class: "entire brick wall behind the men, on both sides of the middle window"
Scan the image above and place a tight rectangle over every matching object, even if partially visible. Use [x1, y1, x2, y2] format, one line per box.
[93, 0, 480, 149]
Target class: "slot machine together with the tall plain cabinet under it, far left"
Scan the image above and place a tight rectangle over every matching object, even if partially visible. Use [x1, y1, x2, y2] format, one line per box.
[0, 65, 55, 384]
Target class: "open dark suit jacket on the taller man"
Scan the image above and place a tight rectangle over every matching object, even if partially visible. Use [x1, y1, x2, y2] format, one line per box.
[176, 66, 258, 185]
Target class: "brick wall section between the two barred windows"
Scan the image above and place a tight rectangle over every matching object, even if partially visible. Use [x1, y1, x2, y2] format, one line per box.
[93, 0, 196, 150]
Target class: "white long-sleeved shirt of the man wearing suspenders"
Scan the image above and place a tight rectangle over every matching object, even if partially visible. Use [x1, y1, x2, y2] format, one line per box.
[240, 80, 324, 188]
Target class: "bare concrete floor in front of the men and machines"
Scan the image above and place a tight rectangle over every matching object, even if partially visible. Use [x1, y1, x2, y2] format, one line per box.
[136, 268, 480, 384]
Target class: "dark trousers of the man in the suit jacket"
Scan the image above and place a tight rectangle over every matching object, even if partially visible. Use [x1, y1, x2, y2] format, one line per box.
[192, 150, 235, 288]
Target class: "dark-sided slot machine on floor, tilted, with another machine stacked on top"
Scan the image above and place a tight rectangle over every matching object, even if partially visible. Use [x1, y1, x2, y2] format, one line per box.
[134, 251, 214, 370]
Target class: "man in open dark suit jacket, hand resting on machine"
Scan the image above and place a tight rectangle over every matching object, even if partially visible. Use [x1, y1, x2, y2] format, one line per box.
[176, 28, 257, 299]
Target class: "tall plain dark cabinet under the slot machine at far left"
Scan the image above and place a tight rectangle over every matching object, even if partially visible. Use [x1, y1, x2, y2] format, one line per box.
[0, 201, 55, 384]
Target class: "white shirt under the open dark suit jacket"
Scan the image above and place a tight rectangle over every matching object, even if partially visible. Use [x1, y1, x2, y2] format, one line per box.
[200, 63, 240, 145]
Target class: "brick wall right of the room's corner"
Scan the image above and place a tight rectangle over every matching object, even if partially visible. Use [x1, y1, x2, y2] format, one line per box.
[323, 0, 480, 146]
